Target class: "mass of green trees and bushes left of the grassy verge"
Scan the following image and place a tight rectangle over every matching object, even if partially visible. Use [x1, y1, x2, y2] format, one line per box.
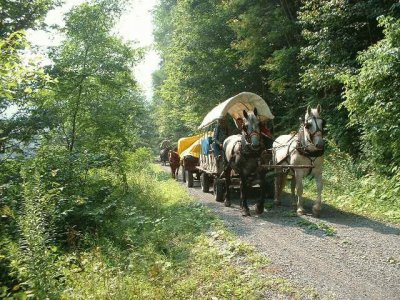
[0, 0, 151, 299]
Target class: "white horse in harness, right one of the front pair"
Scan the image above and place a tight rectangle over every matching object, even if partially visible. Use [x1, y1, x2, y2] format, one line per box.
[272, 104, 325, 217]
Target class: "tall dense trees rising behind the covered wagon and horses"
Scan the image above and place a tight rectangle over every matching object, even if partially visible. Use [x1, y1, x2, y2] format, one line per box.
[154, 0, 399, 173]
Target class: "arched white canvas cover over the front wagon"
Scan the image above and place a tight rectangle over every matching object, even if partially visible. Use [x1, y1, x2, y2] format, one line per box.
[199, 92, 274, 129]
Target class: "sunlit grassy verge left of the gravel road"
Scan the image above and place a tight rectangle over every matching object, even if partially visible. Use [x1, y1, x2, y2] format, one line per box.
[60, 166, 318, 299]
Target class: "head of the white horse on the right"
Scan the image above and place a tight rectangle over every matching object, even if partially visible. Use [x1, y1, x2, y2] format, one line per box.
[302, 104, 325, 151]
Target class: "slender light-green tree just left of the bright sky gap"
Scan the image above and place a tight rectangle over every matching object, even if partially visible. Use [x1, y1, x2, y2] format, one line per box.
[49, 1, 143, 154]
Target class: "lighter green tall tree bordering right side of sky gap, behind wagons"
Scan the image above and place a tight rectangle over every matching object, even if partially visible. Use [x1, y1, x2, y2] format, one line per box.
[155, 0, 250, 139]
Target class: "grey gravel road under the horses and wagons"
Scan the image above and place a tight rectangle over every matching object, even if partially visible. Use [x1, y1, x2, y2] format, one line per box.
[162, 166, 400, 300]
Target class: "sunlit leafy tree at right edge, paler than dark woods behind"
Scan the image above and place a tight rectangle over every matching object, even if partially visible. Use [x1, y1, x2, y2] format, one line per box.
[344, 17, 400, 174]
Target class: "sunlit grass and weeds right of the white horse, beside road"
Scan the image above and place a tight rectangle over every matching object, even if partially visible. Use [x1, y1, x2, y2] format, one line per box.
[296, 152, 400, 224]
